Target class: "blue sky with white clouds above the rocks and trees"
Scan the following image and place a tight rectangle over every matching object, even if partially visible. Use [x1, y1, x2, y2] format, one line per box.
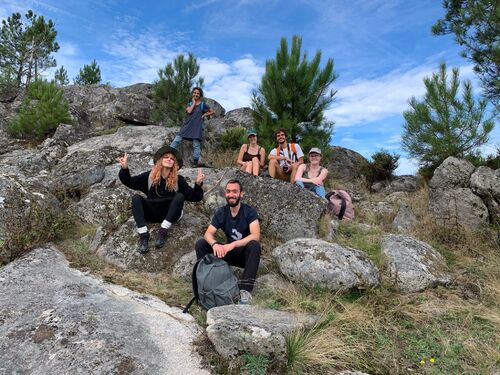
[0, 0, 500, 174]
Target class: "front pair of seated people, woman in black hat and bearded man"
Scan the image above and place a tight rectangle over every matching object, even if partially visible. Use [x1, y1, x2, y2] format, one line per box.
[118, 146, 261, 304]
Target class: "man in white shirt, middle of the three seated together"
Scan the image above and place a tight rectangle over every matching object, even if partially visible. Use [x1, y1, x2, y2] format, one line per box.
[268, 128, 304, 184]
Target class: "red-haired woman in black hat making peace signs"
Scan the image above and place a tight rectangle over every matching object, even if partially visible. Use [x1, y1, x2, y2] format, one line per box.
[118, 146, 205, 254]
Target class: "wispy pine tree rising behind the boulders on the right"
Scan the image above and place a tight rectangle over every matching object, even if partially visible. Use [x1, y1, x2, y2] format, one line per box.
[402, 63, 494, 176]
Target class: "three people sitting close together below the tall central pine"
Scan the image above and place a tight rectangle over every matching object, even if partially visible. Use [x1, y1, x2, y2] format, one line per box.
[237, 129, 328, 198]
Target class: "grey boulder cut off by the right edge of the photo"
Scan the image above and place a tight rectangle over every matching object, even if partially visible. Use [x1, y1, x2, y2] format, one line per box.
[470, 167, 500, 224]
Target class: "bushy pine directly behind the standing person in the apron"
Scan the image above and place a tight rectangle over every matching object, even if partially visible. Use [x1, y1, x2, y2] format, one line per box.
[153, 53, 203, 126]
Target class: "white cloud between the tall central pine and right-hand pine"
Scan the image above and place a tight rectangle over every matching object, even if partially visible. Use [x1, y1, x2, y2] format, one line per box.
[326, 63, 472, 127]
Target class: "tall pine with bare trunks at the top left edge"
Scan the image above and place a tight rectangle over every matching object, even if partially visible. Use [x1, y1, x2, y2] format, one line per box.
[0, 10, 59, 87]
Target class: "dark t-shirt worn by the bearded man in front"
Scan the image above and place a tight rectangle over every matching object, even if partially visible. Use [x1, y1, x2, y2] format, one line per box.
[212, 203, 259, 242]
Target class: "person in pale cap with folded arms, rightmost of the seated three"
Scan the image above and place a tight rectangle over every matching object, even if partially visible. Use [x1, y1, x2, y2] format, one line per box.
[295, 147, 328, 198]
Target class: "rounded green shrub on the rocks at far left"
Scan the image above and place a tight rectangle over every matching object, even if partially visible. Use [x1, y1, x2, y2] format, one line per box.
[7, 80, 71, 139]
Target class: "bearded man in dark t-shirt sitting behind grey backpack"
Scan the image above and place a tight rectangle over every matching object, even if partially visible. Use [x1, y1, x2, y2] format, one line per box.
[195, 180, 261, 304]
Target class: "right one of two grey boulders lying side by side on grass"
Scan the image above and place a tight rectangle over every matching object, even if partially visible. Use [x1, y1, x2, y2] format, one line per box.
[382, 234, 451, 293]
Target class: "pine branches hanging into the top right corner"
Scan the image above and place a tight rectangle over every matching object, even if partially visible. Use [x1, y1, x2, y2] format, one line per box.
[432, 0, 500, 103]
